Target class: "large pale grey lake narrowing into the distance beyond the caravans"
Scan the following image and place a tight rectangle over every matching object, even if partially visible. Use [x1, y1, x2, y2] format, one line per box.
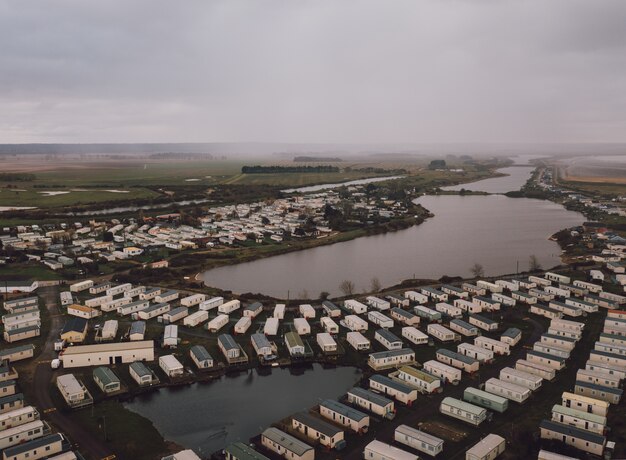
[200, 166, 585, 298]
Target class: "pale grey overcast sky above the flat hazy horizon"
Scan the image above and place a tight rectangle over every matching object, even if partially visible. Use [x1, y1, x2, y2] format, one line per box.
[0, 0, 626, 143]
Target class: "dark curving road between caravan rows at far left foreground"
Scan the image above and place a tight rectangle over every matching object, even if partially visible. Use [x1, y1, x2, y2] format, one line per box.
[30, 288, 113, 460]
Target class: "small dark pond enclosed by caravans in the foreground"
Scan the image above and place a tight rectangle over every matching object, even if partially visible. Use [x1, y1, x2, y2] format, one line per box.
[124, 364, 361, 456]
